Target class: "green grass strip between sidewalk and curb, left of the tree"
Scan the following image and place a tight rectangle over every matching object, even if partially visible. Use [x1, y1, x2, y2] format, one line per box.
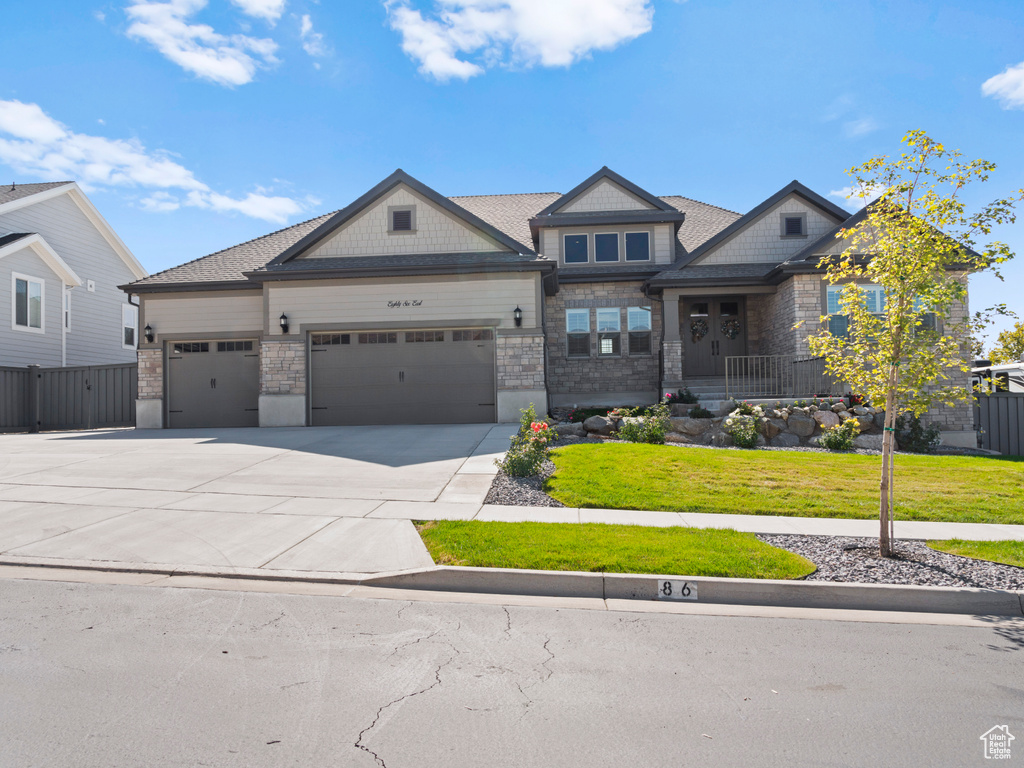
[417, 520, 814, 579]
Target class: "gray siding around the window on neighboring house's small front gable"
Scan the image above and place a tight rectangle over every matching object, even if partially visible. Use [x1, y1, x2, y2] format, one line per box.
[0, 248, 62, 367]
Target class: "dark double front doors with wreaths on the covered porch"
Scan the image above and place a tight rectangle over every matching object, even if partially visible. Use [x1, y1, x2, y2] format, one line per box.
[679, 296, 746, 376]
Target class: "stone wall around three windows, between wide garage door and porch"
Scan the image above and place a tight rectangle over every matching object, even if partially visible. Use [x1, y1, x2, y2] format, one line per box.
[545, 281, 662, 394]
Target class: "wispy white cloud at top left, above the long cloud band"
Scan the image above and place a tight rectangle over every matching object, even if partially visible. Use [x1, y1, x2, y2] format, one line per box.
[125, 0, 278, 86]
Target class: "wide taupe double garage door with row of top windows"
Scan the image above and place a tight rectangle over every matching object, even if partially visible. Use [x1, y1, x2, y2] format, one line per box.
[309, 329, 496, 427]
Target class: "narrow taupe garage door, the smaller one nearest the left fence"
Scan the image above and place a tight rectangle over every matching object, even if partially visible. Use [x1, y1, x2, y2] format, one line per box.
[167, 341, 259, 429]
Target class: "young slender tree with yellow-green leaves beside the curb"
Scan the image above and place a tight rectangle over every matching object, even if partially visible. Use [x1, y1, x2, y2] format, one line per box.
[809, 131, 1024, 557]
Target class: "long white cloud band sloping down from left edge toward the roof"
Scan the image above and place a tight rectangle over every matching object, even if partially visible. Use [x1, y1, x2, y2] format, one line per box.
[0, 100, 315, 223]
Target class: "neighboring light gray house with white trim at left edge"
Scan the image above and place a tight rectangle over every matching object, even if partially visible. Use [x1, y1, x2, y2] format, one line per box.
[0, 181, 147, 368]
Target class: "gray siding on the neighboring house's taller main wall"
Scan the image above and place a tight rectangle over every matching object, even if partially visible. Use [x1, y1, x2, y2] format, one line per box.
[0, 195, 135, 366]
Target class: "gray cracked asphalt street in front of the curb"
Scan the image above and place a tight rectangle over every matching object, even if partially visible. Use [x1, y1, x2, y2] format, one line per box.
[0, 579, 1024, 768]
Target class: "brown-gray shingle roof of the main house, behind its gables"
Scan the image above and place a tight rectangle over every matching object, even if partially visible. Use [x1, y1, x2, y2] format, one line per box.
[131, 193, 739, 289]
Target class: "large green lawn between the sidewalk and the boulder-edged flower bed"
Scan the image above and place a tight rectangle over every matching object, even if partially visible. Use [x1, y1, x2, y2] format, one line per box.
[545, 443, 1024, 524]
